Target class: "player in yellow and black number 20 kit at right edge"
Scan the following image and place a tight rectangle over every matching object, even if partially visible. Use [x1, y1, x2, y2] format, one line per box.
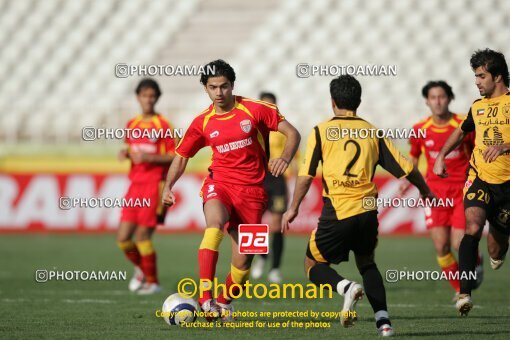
[434, 49, 510, 316]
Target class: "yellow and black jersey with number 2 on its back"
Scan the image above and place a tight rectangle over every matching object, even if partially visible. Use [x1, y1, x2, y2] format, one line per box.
[299, 112, 413, 220]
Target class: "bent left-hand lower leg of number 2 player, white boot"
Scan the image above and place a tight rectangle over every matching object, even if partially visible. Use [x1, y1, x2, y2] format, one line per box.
[305, 256, 363, 327]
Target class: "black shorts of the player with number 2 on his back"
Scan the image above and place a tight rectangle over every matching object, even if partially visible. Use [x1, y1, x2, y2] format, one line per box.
[306, 210, 379, 264]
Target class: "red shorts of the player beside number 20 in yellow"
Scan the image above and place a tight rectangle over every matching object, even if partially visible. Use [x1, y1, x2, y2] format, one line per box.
[425, 183, 466, 230]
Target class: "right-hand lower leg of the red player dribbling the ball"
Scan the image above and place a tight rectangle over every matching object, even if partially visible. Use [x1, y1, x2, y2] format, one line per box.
[217, 227, 253, 322]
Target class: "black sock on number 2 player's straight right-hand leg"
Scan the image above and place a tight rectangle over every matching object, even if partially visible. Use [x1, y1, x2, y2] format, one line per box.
[360, 263, 391, 316]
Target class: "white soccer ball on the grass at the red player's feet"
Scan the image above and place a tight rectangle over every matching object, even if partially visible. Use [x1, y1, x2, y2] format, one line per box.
[161, 293, 198, 326]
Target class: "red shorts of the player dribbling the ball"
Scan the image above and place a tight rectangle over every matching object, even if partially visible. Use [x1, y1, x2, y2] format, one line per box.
[200, 178, 267, 230]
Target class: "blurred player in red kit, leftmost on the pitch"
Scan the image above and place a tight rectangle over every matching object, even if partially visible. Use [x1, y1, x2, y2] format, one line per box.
[117, 79, 176, 295]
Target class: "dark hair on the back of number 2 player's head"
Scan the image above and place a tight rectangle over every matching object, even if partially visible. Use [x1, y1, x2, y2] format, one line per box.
[329, 75, 361, 111]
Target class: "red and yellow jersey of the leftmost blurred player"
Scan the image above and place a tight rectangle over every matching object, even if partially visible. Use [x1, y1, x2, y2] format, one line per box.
[125, 113, 176, 183]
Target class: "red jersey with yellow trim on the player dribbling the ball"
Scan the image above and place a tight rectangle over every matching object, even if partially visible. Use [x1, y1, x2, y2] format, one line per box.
[176, 96, 284, 185]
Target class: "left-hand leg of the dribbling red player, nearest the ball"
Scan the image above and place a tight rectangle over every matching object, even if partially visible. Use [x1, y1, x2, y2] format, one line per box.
[198, 199, 229, 321]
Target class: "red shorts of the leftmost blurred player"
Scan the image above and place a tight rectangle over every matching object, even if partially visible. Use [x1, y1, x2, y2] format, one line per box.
[120, 182, 166, 228]
